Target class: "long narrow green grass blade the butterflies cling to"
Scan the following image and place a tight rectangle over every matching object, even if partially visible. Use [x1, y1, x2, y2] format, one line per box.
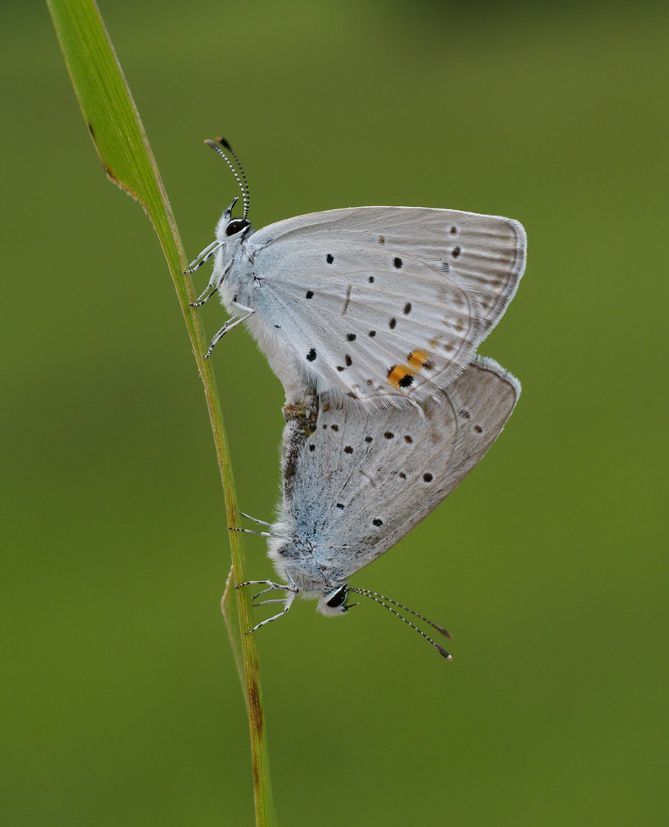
[47, 0, 274, 825]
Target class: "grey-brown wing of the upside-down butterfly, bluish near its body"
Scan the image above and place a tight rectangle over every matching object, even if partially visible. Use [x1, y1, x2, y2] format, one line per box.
[282, 358, 520, 577]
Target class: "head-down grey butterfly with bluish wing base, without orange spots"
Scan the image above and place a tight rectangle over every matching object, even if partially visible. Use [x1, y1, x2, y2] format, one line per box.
[232, 356, 520, 658]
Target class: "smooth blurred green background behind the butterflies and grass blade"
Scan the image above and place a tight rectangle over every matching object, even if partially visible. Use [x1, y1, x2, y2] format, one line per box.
[0, 0, 669, 827]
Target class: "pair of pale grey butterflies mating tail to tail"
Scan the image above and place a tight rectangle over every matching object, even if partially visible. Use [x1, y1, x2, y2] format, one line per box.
[187, 139, 526, 657]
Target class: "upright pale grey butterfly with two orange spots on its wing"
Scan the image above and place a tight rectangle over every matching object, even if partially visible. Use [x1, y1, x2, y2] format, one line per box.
[186, 138, 526, 403]
